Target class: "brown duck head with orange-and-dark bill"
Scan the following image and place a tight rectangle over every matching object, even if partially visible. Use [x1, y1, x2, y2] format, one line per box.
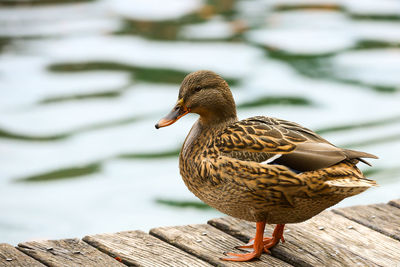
[155, 70, 236, 129]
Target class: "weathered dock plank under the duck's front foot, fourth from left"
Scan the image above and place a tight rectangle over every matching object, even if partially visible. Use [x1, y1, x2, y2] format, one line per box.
[150, 224, 292, 267]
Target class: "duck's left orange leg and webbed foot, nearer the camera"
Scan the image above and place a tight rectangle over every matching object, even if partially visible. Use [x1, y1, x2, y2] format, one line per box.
[221, 222, 265, 261]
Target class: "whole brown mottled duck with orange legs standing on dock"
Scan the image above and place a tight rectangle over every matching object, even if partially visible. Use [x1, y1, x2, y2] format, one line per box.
[156, 71, 377, 261]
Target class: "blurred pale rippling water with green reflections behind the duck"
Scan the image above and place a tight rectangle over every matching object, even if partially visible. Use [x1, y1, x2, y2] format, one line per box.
[0, 0, 400, 244]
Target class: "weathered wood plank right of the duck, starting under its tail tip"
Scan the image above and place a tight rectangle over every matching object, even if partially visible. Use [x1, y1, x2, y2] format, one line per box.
[332, 204, 400, 241]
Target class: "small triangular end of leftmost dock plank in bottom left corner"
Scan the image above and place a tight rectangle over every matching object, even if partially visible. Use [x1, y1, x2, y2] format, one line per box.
[0, 244, 44, 267]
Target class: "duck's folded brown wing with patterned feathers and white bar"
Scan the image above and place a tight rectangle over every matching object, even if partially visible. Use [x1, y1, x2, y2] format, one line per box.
[215, 116, 377, 172]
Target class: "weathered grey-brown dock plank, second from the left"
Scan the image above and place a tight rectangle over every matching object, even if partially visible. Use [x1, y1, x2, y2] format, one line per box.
[18, 238, 124, 267]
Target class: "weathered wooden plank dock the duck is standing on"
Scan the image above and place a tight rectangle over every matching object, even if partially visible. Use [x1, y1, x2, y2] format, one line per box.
[0, 199, 400, 267]
